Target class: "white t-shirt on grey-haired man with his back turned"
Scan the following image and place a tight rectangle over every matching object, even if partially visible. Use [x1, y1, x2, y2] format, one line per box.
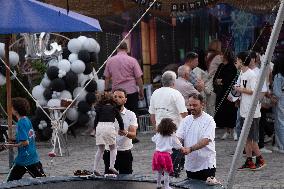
[149, 87, 187, 127]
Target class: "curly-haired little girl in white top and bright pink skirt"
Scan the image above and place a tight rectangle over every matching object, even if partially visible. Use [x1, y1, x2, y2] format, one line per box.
[152, 118, 183, 189]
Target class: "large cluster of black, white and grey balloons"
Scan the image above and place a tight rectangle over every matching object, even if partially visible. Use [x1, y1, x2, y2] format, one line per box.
[32, 36, 103, 139]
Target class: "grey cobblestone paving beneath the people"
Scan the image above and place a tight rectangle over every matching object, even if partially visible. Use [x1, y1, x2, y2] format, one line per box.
[0, 130, 284, 189]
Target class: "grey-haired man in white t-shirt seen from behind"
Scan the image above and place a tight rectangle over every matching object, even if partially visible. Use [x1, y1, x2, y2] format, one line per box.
[149, 71, 187, 128]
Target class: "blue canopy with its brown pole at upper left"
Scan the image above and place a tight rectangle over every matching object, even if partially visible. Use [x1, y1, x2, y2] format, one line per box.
[0, 0, 102, 166]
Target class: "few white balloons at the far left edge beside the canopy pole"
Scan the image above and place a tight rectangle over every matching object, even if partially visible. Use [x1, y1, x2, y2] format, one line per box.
[0, 43, 20, 86]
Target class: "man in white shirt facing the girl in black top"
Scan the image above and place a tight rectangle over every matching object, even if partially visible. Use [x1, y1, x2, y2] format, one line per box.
[103, 89, 138, 174]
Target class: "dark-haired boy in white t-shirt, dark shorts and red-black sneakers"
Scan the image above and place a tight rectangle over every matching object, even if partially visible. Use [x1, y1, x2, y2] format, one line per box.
[235, 52, 266, 171]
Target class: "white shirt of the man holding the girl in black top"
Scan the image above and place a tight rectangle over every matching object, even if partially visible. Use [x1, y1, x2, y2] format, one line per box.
[115, 108, 138, 151]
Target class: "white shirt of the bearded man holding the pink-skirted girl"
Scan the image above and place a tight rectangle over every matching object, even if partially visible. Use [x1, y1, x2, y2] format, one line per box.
[176, 112, 216, 172]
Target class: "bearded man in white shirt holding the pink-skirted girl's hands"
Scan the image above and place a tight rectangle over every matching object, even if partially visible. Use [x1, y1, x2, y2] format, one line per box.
[176, 94, 216, 181]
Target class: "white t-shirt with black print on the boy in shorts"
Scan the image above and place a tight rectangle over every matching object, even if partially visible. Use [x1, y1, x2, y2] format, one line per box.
[238, 69, 261, 118]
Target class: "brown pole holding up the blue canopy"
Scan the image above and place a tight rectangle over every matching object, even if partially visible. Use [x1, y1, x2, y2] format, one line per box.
[5, 35, 14, 168]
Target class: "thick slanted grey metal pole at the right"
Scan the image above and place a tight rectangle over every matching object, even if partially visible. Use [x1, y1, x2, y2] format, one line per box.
[227, 0, 284, 189]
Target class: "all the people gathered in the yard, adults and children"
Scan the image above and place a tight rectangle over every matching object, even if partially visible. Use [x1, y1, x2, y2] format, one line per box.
[1, 40, 284, 189]
